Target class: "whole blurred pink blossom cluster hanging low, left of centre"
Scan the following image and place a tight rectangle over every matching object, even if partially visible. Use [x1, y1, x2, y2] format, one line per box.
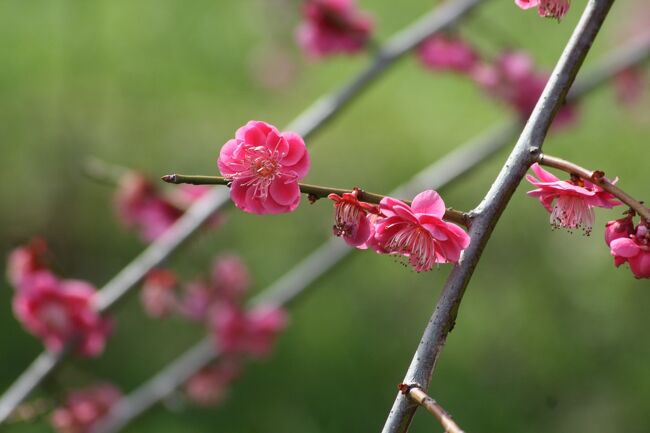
[141, 255, 287, 405]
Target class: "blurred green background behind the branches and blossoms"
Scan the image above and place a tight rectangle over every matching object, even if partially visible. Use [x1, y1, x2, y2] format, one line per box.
[0, 0, 650, 433]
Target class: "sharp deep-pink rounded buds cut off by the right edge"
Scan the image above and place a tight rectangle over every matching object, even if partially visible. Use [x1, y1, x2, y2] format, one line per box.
[605, 215, 650, 278]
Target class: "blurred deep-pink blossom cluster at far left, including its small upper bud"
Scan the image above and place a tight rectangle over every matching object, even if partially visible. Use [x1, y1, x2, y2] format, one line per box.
[7, 239, 111, 357]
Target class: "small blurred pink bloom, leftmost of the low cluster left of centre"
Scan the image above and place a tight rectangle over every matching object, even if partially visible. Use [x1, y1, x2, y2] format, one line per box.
[140, 269, 178, 317]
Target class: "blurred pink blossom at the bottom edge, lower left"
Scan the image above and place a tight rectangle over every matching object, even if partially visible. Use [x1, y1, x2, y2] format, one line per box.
[50, 383, 122, 433]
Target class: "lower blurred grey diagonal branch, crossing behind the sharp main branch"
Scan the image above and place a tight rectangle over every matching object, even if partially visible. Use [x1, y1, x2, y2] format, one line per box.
[83, 31, 650, 433]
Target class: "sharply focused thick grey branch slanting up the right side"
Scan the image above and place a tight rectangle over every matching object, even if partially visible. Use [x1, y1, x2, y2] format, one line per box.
[382, 0, 614, 433]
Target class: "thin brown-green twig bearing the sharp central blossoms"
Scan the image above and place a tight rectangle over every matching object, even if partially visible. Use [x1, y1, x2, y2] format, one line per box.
[161, 174, 470, 227]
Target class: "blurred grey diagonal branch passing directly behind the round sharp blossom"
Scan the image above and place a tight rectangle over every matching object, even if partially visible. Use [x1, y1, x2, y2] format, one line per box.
[0, 0, 487, 424]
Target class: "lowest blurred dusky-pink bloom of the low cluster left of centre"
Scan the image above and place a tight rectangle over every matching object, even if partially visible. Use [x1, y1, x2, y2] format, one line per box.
[185, 360, 242, 406]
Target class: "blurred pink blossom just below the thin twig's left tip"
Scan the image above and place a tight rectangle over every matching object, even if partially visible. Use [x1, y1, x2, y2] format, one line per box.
[115, 171, 220, 241]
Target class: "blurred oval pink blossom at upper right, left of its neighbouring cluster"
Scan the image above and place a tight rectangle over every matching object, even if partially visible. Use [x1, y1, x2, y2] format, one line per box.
[418, 34, 479, 73]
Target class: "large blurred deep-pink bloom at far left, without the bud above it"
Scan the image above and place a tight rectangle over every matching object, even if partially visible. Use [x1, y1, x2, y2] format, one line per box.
[13, 271, 110, 357]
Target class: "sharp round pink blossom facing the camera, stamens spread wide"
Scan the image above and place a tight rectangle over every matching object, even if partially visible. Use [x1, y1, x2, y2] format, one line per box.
[218, 121, 309, 214]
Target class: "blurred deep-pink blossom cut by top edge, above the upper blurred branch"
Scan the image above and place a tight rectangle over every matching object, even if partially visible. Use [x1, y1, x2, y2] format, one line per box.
[296, 0, 373, 57]
